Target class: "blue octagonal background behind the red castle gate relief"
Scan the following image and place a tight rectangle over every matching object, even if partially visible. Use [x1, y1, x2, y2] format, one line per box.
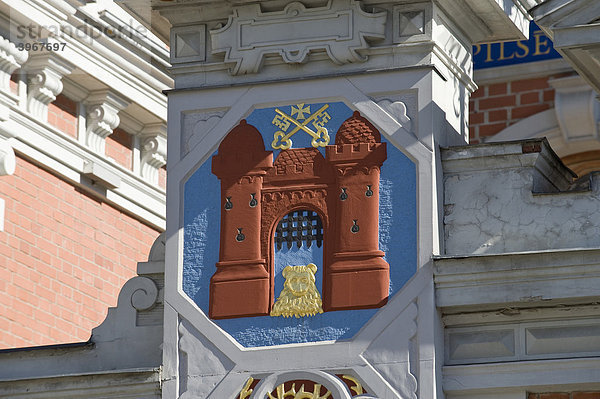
[183, 102, 417, 347]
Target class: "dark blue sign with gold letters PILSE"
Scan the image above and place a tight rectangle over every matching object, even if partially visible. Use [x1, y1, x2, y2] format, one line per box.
[473, 22, 561, 69]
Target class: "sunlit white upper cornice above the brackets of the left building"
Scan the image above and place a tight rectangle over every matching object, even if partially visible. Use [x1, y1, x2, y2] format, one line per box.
[2, 0, 173, 120]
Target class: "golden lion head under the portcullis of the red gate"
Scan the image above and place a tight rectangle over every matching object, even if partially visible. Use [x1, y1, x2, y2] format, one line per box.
[271, 263, 323, 318]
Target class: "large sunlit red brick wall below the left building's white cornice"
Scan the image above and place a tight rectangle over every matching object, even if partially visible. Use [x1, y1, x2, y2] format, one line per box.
[0, 157, 159, 348]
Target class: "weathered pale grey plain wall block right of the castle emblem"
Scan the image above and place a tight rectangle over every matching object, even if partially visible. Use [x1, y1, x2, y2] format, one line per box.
[442, 142, 600, 255]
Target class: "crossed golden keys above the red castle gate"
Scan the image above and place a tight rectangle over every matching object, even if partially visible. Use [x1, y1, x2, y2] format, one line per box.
[271, 104, 331, 150]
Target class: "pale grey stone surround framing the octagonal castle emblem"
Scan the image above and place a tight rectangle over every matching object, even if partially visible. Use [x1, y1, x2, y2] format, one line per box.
[163, 72, 443, 399]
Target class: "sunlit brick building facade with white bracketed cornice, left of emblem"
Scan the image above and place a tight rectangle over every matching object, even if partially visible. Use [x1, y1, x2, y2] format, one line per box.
[0, 1, 172, 348]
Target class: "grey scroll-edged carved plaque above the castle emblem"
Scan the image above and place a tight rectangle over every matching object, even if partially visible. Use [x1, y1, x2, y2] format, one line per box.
[210, 0, 386, 75]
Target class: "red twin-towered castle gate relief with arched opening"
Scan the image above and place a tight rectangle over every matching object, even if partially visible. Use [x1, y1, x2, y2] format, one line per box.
[209, 112, 389, 319]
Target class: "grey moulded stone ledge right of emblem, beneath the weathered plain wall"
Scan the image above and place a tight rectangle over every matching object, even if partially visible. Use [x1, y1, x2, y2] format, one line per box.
[434, 248, 600, 311]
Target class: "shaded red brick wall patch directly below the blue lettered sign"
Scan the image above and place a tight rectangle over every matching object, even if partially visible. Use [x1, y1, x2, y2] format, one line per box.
[469, 74, 565, 144]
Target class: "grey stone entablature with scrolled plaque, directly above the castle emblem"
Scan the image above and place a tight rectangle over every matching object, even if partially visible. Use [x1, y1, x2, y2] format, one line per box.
[157, 0, 502, 93]
